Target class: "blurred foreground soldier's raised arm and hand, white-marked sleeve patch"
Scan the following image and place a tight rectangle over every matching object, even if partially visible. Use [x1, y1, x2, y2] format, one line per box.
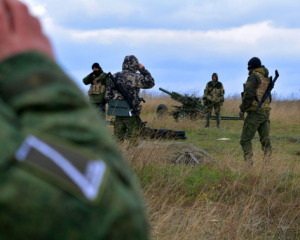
[0, 0, 148, 240]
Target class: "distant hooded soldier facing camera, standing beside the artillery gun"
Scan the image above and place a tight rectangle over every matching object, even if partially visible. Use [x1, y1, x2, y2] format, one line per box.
[203, 73, 225, 128]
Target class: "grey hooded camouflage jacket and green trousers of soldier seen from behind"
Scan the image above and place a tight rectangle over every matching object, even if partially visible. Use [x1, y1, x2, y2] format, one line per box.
[106, 55, 154, 141]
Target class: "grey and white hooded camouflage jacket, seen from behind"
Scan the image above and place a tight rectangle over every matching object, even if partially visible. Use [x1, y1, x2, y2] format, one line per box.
[105, 55, 154, 111]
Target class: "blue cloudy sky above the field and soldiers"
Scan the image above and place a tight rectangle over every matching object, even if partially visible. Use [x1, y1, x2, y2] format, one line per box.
[23, 0, 300, 97]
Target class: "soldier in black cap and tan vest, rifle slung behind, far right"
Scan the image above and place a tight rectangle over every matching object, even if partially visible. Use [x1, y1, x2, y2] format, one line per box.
[240, 57, 272, 166]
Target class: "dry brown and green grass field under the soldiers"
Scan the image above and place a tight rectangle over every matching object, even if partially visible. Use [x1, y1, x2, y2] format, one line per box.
[118, 96, 300, 239]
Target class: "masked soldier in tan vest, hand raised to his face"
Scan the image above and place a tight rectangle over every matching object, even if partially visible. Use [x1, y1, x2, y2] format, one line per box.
[82, 63, 109, 120]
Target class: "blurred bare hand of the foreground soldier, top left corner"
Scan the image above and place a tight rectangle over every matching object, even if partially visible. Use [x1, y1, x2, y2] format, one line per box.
[0, 0, 54, 61]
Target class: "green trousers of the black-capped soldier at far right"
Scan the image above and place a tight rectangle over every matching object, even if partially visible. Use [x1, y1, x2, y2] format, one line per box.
[240, 111, 272, 164]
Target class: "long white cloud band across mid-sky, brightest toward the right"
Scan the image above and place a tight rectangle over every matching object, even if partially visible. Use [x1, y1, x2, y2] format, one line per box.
[49, 21, 300, 57]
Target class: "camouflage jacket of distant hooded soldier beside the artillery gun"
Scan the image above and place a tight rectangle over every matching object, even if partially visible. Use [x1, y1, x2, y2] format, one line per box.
[203, 73, 225, 103]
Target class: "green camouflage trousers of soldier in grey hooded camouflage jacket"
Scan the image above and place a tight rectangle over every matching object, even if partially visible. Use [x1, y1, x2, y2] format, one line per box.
[114, 116, 140, 142]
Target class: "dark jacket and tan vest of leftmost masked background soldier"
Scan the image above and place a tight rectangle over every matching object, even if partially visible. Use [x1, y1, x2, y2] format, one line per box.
[82, 72, 109, 104]
